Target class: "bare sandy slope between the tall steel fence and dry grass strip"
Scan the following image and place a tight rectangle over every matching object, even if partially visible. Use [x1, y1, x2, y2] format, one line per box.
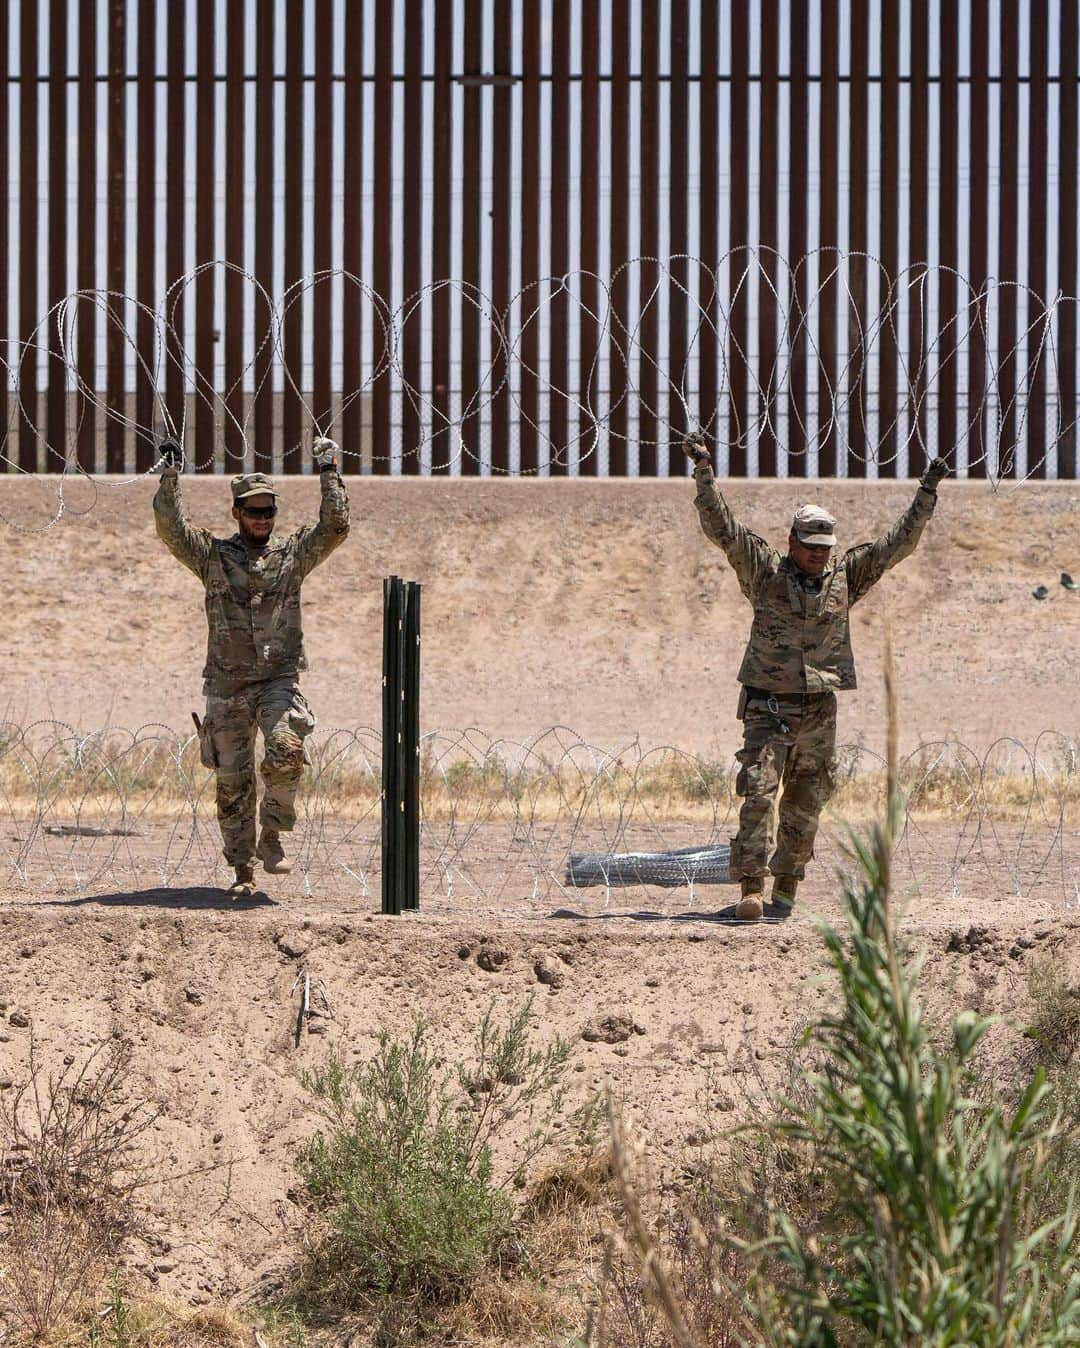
[0, 477, 1080, 759]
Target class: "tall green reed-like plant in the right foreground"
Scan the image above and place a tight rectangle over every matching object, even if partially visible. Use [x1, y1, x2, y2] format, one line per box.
[613, 641, 1080, 1348]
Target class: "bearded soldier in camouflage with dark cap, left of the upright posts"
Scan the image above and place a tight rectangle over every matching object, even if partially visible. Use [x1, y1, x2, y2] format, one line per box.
[154, 439, 349, 894]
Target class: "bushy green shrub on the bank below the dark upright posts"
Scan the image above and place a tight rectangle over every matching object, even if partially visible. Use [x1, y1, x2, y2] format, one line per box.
[291, 1000, 569, 1306]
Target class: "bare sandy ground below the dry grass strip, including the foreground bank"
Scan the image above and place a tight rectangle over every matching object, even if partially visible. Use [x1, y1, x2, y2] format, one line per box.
[0, 798, 1080, 1304]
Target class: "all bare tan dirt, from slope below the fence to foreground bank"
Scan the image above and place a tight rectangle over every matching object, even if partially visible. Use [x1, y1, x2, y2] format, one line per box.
[0, 479, 1080, 1326]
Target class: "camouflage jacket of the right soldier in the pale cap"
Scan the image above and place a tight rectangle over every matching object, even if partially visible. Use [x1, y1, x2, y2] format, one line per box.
[694, 465, 937, 693]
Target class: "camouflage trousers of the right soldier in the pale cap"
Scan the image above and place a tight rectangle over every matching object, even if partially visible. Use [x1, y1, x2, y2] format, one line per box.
[731, 693, 836, 880]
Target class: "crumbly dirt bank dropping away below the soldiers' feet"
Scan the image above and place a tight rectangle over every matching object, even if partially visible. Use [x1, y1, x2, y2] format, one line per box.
[0, 903, 1080, 1304]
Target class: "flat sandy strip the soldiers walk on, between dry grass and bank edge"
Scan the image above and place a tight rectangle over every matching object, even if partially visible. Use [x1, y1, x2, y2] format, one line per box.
[0, 813, 1080, 925]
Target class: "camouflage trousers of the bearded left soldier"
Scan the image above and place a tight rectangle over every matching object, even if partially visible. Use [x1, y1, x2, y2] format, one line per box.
[200, 678, 316, 865]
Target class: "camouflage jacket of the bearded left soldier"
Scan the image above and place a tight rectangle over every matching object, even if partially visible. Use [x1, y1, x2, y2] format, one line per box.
[154, 470, 349, 696]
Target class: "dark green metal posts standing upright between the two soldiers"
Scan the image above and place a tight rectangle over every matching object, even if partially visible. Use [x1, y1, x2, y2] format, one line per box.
[383, 576, 421, 914]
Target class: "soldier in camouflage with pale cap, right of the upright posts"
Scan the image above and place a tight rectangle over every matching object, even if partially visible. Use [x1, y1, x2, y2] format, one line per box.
[685, 437, 948, 921]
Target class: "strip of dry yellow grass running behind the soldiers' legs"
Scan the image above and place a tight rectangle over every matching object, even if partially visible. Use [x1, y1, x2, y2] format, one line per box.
[0, 727, 1080, 825]
